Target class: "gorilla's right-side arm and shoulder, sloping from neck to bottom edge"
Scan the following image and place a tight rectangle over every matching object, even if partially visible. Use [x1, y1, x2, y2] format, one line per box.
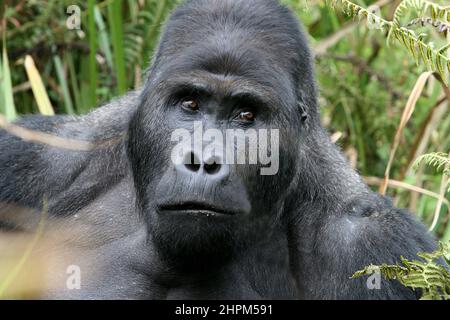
[288, 130, 436, 299]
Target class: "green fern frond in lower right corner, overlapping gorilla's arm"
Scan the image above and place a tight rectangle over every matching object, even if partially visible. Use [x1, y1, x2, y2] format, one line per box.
[352, 243, 450, 300]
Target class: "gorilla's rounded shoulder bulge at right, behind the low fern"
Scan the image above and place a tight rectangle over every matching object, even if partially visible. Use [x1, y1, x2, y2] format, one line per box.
[292, 193, 436, 299]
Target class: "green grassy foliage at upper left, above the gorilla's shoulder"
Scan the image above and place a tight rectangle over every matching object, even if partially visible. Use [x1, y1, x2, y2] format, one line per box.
[0, 0, 179, 114]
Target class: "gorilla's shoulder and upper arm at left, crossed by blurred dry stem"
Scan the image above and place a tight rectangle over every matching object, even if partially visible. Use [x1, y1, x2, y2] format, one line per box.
[0, 92, 139, 214]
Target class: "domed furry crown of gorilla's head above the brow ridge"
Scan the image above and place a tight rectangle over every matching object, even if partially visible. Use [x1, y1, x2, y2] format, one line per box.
[153, 0, 312, 84]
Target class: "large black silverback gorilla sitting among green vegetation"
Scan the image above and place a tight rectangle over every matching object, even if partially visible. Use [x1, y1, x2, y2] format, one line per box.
[0, 0, 435, 299]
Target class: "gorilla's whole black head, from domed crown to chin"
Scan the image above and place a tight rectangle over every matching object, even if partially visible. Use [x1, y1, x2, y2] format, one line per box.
[128, 0, 318, 261]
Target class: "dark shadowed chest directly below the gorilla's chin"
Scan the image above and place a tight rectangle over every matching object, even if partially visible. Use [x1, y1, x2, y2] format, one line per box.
[153, 241, 298, 300]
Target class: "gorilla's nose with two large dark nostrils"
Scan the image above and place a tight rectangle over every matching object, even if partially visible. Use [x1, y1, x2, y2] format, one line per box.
[178, 151, 228, 177]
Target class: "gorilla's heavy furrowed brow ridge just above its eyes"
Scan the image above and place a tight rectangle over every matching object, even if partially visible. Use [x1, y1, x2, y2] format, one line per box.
[147, 48, 296, 109]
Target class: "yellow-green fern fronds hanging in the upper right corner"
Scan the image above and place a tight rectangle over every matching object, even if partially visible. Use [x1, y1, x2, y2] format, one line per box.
[333, 0, 450, 83]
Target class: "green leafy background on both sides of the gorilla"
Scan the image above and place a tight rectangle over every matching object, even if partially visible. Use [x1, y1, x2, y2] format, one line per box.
[0, 0, 450, 240]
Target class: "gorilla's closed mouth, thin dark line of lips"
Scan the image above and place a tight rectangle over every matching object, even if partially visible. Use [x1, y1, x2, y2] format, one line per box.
[158, 201, 238, 216]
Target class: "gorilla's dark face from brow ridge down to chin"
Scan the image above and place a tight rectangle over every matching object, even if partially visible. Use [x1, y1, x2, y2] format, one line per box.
[128, 73, 293, 268]
